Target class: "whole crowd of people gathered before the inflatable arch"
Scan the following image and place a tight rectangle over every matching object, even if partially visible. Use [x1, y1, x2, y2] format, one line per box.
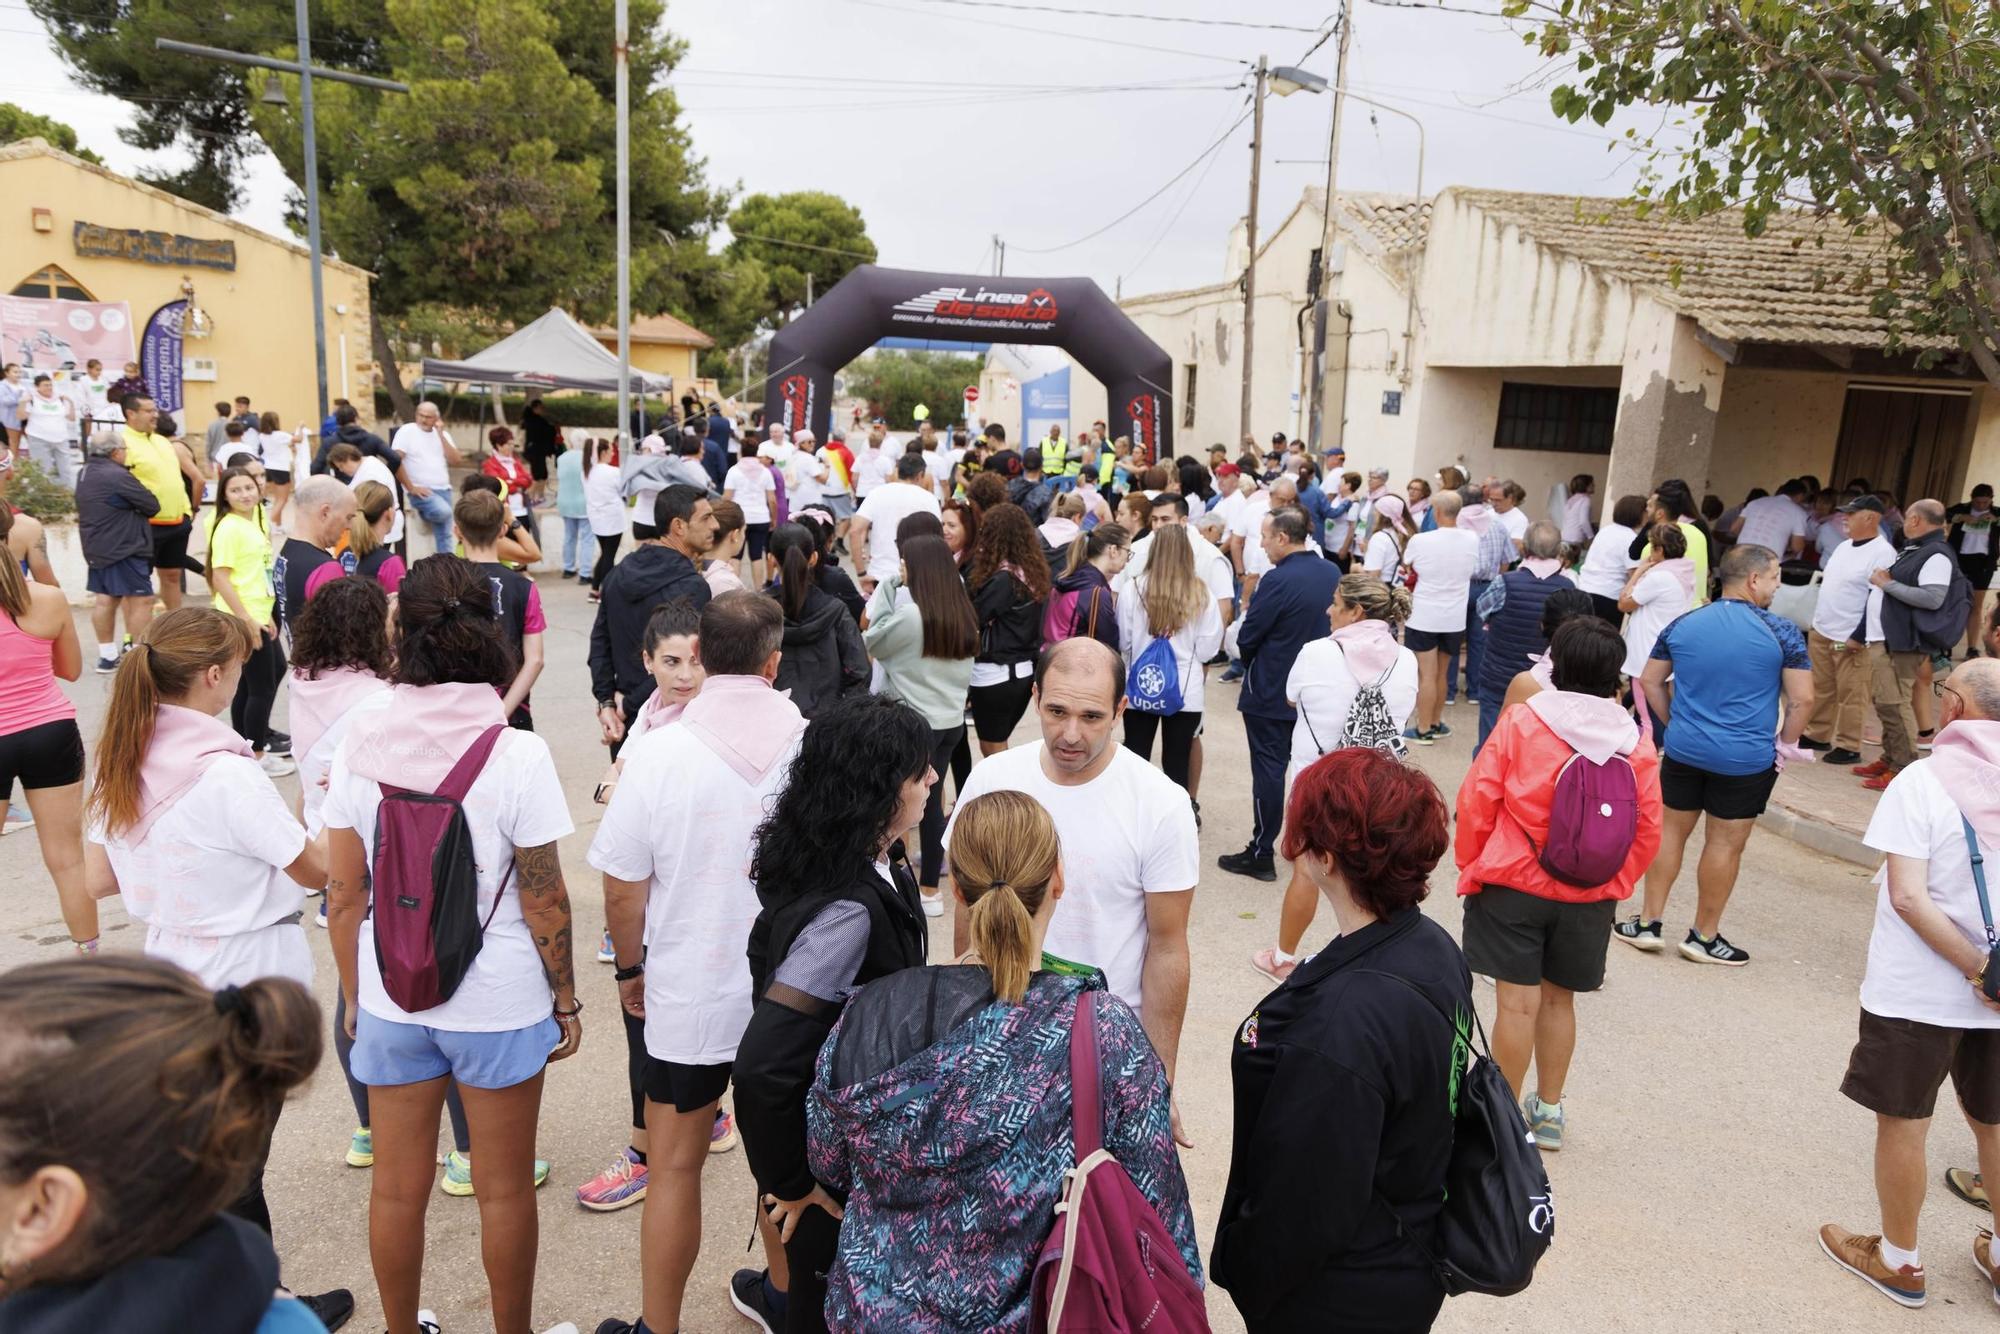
[11, 386, 2000, 1334]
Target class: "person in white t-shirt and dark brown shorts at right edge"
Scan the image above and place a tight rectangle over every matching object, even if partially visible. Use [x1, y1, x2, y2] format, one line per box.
[1820, 660, 2000, 1306]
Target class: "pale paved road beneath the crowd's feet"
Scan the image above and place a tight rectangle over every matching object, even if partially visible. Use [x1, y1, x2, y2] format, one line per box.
[0, 576, 1994, 1334]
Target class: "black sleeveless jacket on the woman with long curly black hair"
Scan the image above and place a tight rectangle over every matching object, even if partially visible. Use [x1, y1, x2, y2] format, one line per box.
[734, 844, 930, 1200]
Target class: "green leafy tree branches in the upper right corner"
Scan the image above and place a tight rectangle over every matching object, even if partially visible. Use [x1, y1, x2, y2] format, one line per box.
[1506, 0, 2000, 384]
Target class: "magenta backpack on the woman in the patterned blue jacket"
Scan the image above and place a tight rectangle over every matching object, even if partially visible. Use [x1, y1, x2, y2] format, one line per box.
[1030, 992, 1208, 1334]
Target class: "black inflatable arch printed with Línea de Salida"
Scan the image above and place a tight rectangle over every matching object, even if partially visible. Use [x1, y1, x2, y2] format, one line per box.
[764, 264, 1174, 458]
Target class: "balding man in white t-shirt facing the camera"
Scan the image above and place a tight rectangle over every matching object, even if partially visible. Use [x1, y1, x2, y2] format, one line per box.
[944, 638, 1202, 1132]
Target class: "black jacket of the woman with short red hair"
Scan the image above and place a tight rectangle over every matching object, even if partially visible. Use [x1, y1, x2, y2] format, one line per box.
[1208, 904, 1472, 1330]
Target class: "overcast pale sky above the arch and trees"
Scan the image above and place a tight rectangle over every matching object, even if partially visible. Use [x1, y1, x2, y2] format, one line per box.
[0, 0, 1660, 294]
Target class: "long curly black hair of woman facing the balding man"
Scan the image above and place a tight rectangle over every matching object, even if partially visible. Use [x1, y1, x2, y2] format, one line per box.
[750, 694, 930, 908]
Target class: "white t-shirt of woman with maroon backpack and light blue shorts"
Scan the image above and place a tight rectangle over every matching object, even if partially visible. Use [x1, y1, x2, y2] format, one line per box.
[320, 708, 576, 1032]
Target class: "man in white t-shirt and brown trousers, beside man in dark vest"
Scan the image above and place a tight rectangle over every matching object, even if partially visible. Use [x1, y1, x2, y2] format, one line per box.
[1798, 496, 1896, 764]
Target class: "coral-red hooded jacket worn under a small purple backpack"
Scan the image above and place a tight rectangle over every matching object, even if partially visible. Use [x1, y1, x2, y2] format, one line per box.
[1454, 690, 1660, 904]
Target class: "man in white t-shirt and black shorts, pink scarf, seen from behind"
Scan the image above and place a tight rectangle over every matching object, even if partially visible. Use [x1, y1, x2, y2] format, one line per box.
[590, 590, 806, 1330]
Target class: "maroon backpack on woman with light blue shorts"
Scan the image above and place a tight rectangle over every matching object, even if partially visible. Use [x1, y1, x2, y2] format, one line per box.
[370, 722, 514, 1014]
